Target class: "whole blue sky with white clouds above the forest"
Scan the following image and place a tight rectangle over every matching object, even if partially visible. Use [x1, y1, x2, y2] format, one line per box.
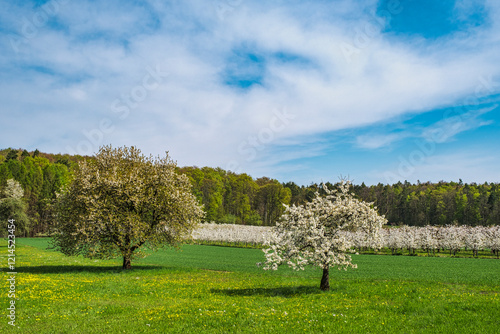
[0, 0, 500, 185]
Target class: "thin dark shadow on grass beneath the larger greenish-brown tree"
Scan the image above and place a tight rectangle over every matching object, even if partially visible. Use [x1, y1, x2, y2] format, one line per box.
[12, 265, 167, 274]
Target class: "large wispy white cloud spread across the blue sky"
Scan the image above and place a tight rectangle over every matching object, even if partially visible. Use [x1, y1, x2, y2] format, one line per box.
[0, 0, 500, 183]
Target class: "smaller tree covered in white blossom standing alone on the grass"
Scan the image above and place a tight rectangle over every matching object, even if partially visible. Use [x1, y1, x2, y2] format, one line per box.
[264, 181, 387, 291]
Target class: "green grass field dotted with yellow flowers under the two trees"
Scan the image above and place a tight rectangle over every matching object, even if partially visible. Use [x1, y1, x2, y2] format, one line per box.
[0, 239, 500, 333]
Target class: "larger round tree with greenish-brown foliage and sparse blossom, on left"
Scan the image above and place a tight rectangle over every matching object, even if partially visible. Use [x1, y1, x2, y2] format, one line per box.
[53, 146, 202, 269]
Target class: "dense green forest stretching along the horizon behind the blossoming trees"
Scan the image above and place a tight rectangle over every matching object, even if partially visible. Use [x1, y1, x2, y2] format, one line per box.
[0, 149, 500, 236]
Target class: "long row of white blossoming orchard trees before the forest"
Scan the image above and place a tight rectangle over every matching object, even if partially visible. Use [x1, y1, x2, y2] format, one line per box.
[192, 223, 500, 257]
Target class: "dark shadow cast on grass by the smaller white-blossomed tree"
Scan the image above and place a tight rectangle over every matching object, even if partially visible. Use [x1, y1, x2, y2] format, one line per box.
[210, 286, 323, 298]
